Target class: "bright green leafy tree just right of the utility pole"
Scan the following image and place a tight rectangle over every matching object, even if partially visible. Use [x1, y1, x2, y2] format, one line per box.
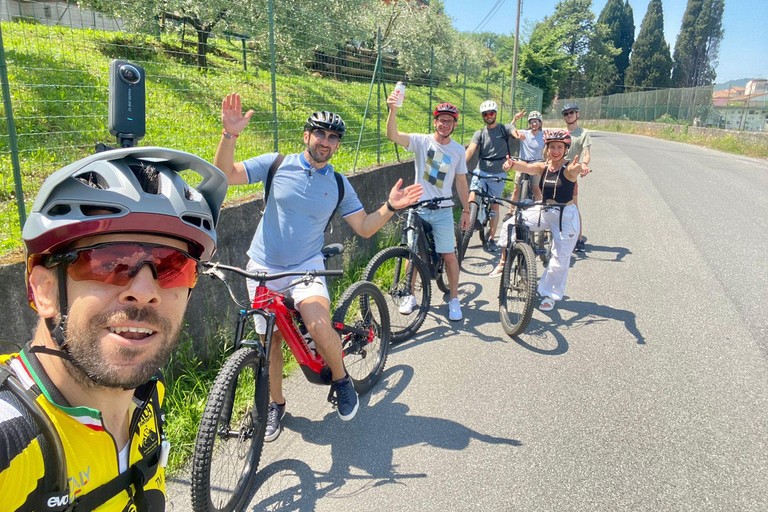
[518, 18, 576, 109]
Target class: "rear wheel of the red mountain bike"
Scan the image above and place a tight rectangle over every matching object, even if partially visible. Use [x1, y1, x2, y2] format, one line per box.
[333, 281, 390, 395]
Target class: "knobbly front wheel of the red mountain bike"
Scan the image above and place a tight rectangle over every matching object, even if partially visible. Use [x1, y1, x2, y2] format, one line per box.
[192, 347, 269, 512]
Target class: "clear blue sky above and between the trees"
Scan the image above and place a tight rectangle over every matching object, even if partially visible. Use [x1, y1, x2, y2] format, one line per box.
[444, 0, 768, 83]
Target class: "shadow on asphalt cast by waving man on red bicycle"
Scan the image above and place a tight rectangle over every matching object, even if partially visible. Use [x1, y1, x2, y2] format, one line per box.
[249, 365, 522, 511]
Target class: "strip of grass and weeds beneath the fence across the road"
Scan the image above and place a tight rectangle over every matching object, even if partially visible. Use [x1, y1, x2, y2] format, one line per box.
[586, 119, 768, 158]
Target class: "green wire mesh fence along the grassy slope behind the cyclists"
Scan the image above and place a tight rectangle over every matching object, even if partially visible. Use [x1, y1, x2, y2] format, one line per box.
[0, 0, 541, 252]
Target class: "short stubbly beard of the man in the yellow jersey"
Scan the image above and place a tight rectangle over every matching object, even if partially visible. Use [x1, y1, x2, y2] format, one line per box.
[62, 306, 181, 390]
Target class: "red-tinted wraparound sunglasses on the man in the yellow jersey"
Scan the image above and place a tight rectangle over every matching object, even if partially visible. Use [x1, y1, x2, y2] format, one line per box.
[45, 242, 199, 288]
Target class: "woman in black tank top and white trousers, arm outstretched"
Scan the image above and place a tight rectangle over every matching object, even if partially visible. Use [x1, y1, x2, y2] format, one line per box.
[490, 130, 584, 311]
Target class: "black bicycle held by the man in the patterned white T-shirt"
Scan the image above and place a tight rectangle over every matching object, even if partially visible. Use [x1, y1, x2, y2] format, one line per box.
[363, 197, 461, 343]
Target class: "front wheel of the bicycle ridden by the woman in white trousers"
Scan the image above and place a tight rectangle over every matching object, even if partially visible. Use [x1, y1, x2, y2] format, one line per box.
[499, 243, 537, 337]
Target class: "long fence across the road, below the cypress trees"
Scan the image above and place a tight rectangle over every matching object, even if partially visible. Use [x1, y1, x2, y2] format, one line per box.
[545, 86, 768, 131]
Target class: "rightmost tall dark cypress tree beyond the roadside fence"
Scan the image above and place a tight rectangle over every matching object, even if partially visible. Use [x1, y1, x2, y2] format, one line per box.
[672, 0, 725, 87]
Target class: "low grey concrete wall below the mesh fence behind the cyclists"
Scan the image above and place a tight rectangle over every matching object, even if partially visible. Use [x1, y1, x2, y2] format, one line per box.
[0, 159, 414, 353]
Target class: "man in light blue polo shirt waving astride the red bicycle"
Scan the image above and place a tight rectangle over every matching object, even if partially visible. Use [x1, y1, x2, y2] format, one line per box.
[213, 94, 422, 441]
